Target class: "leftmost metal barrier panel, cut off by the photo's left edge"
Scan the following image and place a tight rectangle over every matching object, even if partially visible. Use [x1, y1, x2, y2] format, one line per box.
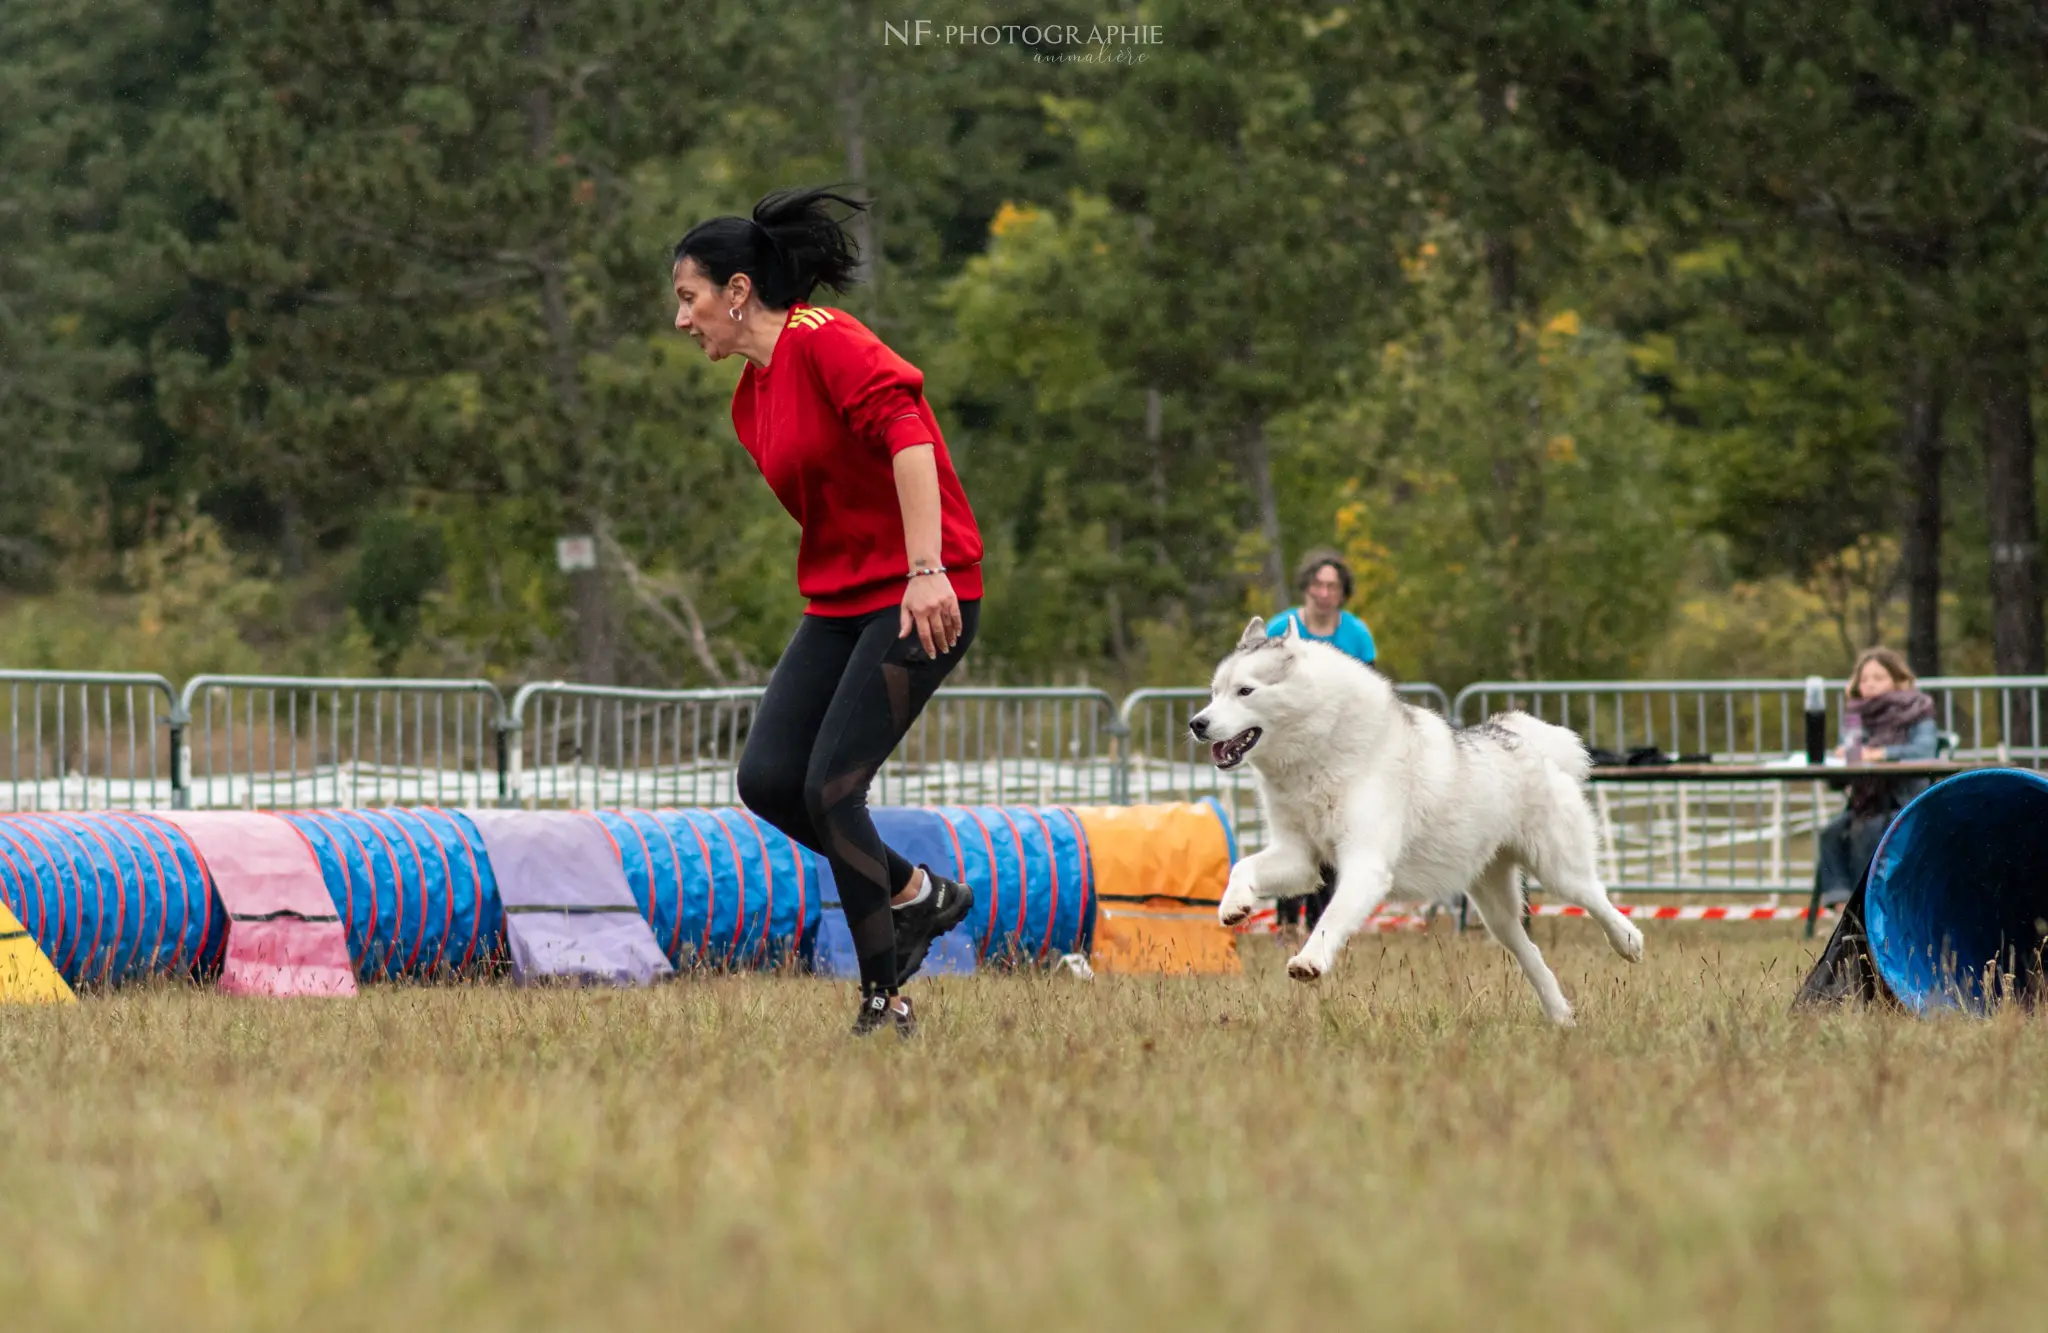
[0, 672, 178, 811]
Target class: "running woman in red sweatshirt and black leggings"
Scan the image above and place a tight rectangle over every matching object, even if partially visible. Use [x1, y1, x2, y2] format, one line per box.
[674, 190, 981, 1036]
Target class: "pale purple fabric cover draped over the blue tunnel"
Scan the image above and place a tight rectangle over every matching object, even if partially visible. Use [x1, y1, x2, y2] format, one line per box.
[467, 811, 676, 985]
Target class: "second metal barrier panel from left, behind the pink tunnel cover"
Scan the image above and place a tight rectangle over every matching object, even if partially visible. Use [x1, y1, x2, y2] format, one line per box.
[176, 676, 506, 809]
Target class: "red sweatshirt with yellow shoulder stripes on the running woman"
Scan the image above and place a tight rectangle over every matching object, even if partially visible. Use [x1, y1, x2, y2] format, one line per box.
[733, 301, 981, 616]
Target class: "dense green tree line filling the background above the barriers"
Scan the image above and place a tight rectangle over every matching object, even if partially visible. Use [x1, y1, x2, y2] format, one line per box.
[0, 0, 2048, 686]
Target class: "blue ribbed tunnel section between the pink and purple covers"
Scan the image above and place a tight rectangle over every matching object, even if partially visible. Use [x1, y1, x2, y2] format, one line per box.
[281, 807, 504, 981]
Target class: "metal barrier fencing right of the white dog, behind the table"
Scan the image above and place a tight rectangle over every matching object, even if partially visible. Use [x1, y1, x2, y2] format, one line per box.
[1454, 676, 2048, 893]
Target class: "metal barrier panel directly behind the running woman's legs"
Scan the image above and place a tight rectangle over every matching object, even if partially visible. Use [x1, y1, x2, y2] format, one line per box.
[506, 682, 1124, 807]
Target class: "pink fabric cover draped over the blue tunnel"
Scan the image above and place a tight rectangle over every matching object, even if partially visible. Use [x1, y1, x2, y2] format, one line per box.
[162, 811, 356, 995]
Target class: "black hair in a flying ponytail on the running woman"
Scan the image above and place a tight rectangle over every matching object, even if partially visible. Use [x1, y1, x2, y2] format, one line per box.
[670, 190, 868, 309]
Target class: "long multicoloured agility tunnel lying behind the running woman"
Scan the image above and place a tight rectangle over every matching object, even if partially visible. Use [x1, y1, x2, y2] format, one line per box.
[0, 801, 1235, 999]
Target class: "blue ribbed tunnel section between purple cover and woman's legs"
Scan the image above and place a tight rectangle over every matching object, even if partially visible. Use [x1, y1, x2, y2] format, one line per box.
[594, 809, 815, 971]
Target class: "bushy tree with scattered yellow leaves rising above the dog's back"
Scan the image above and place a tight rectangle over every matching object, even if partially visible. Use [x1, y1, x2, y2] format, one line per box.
[1288, 229, 1686, 680]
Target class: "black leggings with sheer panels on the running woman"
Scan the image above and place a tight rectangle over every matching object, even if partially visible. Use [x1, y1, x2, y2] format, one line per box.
[739, 602, 981, 989]
